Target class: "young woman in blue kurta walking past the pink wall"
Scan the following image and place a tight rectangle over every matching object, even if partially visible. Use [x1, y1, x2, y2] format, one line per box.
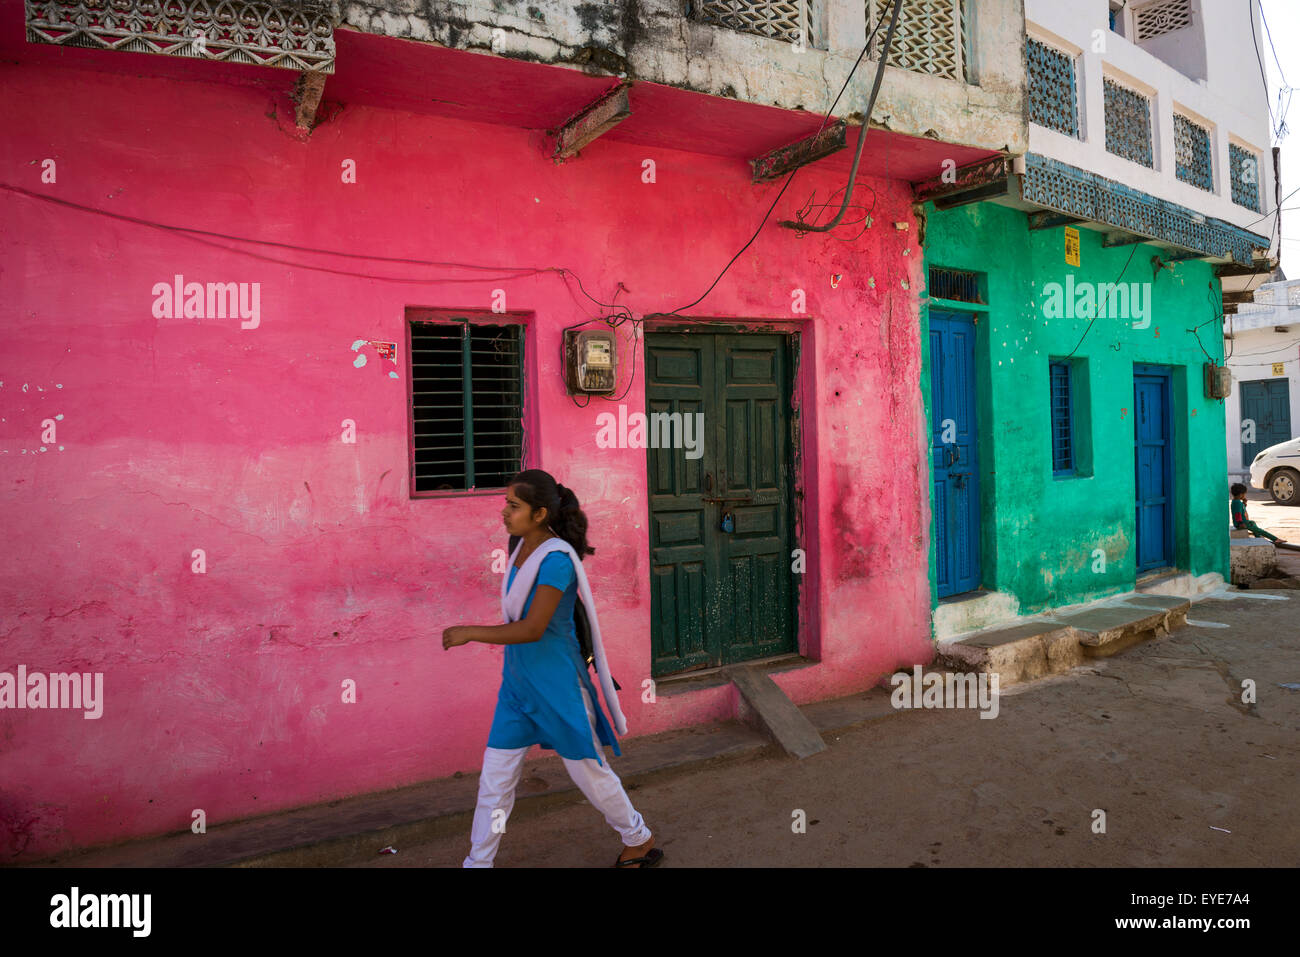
[442, 468, 663, 867]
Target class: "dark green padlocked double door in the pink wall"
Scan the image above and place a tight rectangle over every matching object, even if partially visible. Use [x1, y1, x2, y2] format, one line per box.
[646, 332, 797, 677]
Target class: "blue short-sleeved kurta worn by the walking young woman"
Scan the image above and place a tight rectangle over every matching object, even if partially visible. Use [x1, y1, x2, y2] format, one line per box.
[488, 551, 623, 765]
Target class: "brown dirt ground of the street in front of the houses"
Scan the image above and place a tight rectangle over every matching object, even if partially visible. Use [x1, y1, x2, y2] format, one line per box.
[351, 582, 1300, 867]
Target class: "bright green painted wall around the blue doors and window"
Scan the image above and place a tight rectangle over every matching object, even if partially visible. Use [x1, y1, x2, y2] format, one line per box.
[922, 203, 1229, 614]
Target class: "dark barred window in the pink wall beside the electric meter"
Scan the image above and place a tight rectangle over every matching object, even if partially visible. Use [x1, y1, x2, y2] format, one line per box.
[411, 319, 524, 493]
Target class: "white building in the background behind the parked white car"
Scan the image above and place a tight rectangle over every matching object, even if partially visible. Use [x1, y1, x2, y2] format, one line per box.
[1223, 280, 1300, 481]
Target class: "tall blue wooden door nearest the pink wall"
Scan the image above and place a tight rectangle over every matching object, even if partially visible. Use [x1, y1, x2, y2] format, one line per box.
[930, 309, 980, 598]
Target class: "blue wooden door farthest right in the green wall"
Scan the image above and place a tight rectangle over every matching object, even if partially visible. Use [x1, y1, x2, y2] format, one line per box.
[1134, 365, 1174, 573]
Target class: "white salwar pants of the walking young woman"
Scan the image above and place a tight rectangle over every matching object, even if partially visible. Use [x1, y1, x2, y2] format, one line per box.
[463, 688, 650, 867]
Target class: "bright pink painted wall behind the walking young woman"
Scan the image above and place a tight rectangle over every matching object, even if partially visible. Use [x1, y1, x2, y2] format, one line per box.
[0, 35, 932, 858]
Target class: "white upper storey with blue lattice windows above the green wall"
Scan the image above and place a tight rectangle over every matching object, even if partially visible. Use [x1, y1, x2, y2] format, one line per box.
[1024, 0, 1277, 269]
